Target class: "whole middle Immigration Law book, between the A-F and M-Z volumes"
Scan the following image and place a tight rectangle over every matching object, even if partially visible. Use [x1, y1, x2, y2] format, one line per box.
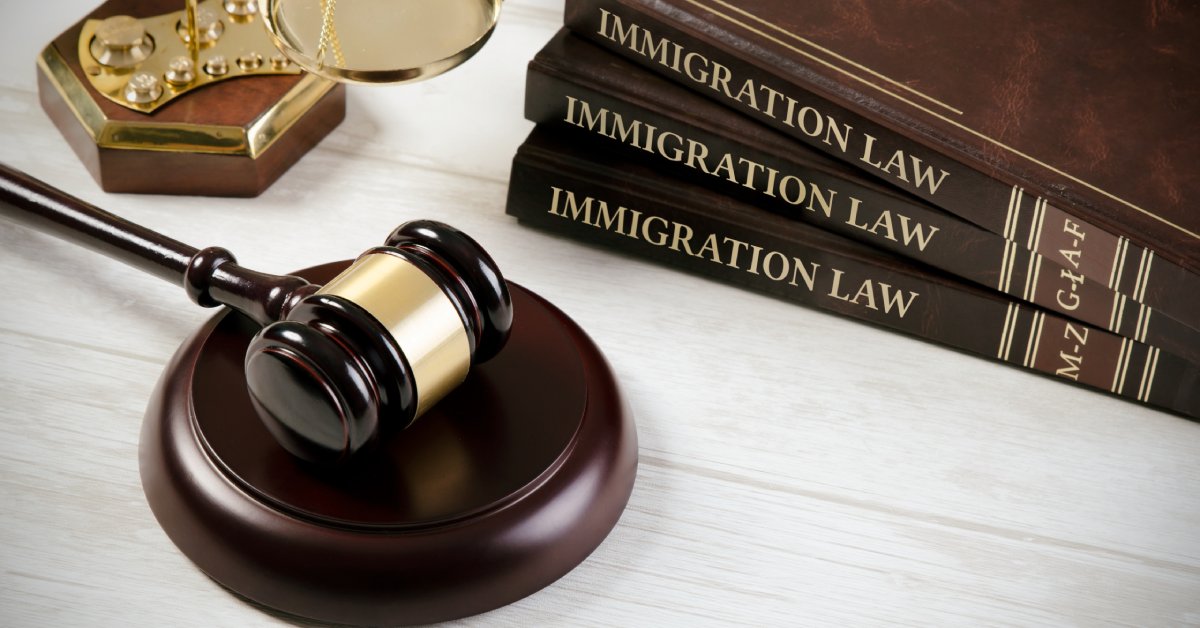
[526, 30, 1200, 364]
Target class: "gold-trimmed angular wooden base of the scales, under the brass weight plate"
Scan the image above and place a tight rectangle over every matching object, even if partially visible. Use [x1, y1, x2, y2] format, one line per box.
[37, 0, 346, 197]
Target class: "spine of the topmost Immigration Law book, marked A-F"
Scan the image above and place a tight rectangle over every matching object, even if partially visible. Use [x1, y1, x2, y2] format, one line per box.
[565, 0, 1200, 329]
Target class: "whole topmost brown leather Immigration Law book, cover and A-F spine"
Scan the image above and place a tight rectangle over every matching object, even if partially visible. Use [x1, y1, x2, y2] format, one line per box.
[565, 0, 1200, 328]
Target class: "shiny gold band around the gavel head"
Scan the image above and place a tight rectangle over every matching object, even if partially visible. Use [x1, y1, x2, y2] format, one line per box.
[317, 252, 470, 417]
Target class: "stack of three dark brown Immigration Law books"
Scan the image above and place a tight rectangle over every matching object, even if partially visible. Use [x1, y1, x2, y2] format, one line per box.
[508, 0, 1200, 418]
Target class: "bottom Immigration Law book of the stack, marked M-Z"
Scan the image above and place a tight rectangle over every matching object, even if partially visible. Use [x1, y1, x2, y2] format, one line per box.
[508, 127, 1200, 419]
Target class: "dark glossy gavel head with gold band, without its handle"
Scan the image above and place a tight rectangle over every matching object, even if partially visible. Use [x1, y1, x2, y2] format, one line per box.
[246, 221, 512, 463]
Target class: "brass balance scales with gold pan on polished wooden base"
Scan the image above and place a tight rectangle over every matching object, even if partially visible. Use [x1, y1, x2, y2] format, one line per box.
[37, 0, 502, 196]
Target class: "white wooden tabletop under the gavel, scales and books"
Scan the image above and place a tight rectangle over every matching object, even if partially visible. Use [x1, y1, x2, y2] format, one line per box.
[0, 0, 1200, 627]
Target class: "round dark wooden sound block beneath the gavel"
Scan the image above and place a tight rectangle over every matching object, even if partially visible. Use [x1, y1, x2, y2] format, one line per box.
[140, 264, 637, 624]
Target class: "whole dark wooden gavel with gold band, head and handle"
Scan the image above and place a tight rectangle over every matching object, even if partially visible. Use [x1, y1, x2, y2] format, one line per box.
[0, 165, 512, 463]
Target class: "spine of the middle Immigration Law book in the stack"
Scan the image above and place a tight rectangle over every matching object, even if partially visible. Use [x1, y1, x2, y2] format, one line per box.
[526, 49, 1200, 363]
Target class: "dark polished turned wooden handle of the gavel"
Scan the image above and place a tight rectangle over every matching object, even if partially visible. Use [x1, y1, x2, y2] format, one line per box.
[0, 163, 317, 324]
